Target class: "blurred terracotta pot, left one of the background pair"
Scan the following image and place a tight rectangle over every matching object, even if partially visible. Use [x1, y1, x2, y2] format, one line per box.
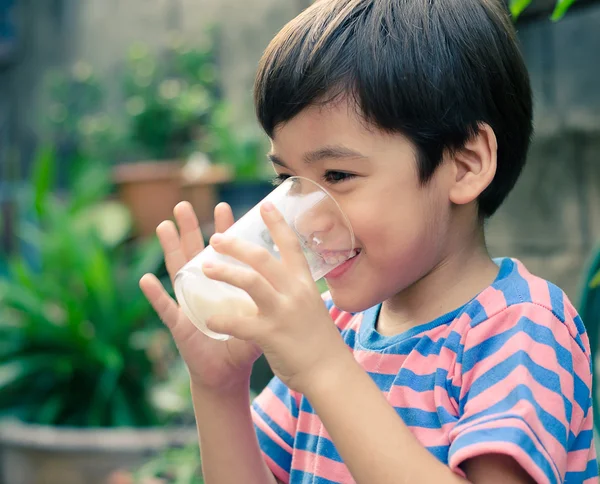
[114, 162, 182, 237]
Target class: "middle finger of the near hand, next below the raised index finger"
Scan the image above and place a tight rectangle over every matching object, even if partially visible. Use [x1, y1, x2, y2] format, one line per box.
[210, 234, 290, 291]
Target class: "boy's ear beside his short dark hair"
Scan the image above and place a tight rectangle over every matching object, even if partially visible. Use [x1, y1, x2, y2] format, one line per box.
[450, 123, 498, 205]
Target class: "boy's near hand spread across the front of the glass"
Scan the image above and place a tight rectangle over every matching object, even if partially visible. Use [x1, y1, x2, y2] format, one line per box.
[204, 203, 349, 391]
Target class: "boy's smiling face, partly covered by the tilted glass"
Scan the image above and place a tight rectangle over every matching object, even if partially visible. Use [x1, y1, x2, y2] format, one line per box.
[270, 102, 451, 312]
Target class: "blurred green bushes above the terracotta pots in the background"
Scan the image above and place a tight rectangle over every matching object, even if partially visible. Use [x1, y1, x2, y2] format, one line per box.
[45, 29, 268, 180]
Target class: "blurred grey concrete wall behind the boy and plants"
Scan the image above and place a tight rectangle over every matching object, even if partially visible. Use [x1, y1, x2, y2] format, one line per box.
[0, 0, 600, 297]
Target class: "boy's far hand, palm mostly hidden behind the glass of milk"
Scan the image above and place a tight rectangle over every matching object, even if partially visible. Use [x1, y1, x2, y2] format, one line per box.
[140, 202, 260, 392]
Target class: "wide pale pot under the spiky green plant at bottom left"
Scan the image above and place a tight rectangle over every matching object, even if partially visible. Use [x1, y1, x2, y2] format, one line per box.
[0, 422, 199, 484]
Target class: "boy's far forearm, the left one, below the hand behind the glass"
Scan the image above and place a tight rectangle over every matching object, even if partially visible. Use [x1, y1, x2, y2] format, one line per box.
[191, 384, 277, 484]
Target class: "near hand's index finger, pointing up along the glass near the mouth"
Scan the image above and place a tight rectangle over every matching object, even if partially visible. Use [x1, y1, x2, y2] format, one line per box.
[260, 202, 309, 272]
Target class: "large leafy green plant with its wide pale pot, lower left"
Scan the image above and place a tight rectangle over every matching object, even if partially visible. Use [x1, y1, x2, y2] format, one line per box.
[0, 152, 196, 484]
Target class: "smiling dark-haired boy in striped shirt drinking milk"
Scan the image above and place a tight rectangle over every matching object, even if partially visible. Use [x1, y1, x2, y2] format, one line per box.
[141, 0, 598, 484]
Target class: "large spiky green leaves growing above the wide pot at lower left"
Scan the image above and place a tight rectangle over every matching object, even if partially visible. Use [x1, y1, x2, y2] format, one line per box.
[0, 149, 178, 427]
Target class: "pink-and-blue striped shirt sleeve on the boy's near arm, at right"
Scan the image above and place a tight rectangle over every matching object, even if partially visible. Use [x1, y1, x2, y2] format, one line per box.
[448, 303, 591, 483]
